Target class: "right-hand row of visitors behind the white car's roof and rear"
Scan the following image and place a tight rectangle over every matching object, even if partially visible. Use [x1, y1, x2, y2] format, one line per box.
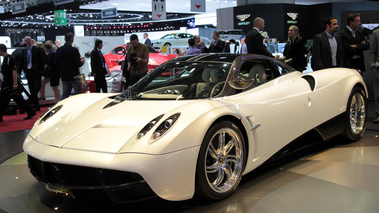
[186, 13, 379, 123]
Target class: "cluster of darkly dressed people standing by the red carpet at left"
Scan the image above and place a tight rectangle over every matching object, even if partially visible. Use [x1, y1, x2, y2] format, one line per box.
[0, 33, 84, 122]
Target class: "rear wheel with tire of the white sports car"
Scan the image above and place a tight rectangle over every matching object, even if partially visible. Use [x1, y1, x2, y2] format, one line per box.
[344, 87, 367, 141]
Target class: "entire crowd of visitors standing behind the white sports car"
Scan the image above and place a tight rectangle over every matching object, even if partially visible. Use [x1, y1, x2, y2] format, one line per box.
[0, 13, 379, 123]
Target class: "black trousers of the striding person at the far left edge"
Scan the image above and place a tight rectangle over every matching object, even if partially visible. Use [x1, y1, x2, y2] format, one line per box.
[0, 82, 34, 118]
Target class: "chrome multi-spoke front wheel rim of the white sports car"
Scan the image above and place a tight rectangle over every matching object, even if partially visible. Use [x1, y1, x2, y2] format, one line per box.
[204, 127, 244, 193]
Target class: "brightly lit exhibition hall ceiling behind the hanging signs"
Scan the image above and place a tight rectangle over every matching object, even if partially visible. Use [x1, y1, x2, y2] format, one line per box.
[0, 0, 378, 27]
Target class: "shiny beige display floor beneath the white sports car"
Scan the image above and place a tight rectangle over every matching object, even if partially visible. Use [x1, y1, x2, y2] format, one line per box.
[0, 130, 379, 213]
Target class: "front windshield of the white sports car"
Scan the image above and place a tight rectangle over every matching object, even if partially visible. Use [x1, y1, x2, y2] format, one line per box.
[116, 61, 232, 100]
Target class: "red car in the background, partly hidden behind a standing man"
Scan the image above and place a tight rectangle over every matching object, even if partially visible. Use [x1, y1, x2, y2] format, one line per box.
[104, 45, 178, 74]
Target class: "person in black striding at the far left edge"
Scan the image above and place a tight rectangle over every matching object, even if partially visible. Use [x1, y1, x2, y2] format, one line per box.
[0, 44, 36, 122]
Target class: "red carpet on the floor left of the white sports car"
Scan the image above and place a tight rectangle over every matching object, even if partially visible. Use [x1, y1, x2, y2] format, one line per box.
[0, 106, 50, 133]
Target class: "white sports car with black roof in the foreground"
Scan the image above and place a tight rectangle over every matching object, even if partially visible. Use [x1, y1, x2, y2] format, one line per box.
[23, 54, 367, 202]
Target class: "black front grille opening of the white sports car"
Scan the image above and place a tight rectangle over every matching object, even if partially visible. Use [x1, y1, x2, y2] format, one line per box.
[28, 155, 155, 202]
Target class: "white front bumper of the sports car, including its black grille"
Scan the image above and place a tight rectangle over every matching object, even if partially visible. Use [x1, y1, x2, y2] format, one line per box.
[23, 135, 199, 202]
